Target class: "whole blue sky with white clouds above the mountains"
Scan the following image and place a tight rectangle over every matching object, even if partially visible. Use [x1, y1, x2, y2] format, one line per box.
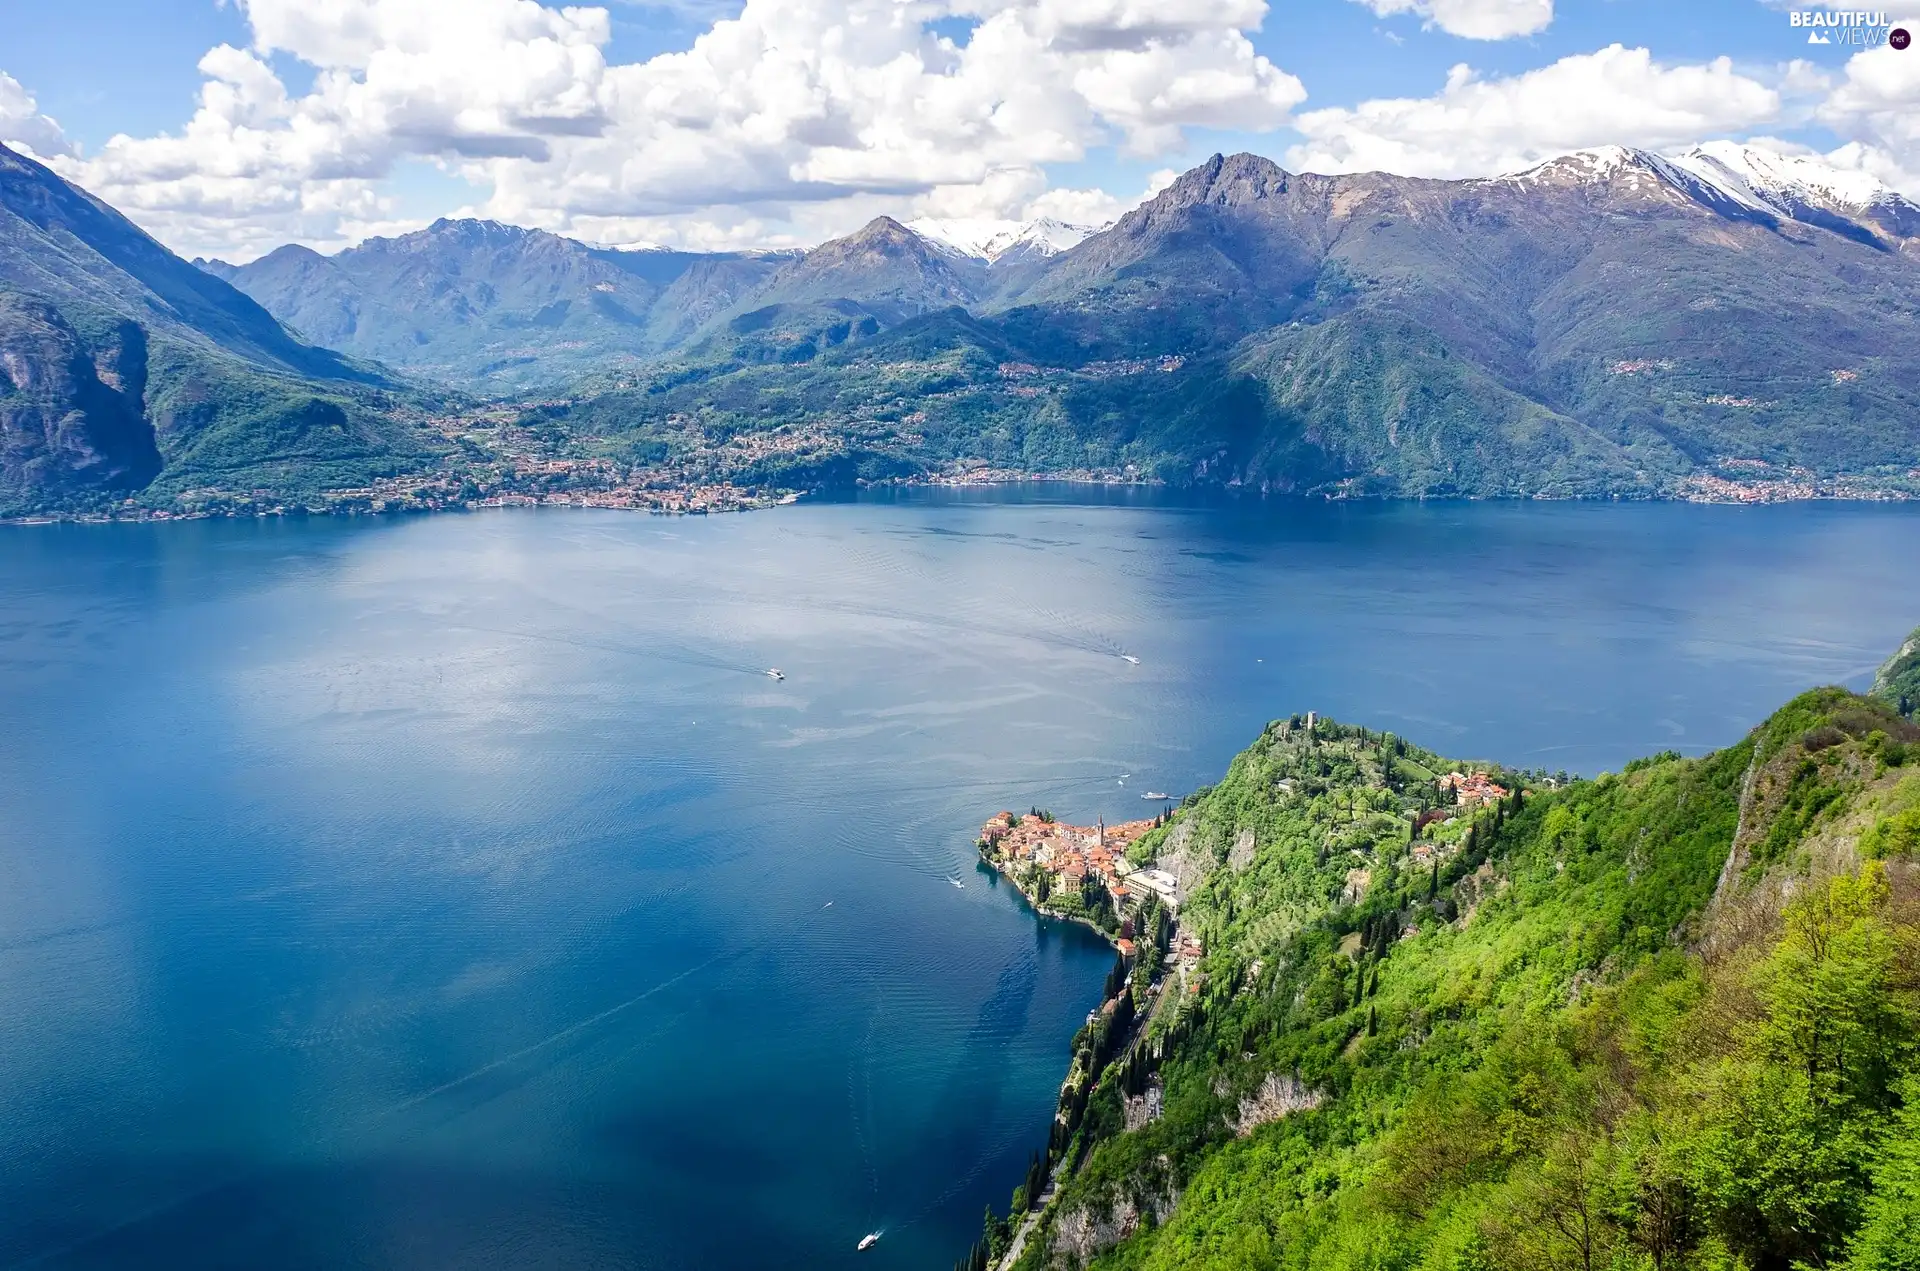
[0, 0, 1920, 263]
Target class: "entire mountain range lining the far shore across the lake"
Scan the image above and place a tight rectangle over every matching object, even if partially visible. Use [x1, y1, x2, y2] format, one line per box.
[0, 142, 1920, 505]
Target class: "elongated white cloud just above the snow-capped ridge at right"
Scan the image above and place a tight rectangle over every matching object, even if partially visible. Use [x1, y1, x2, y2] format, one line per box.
[1286, 44, 1782, 177]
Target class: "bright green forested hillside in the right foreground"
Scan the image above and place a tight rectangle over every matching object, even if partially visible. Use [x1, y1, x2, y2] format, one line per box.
[975, 668, 1920, 1271]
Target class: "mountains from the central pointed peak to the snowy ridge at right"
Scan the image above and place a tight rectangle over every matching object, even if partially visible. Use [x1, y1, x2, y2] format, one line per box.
[518, 146, 1920, 497]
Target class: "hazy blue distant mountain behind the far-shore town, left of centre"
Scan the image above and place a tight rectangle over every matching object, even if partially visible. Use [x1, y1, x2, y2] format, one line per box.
[200, 219, 791, 394]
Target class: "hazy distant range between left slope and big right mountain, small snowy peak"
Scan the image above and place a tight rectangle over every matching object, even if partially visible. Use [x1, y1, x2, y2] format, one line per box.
[194, 217, 1094, 396]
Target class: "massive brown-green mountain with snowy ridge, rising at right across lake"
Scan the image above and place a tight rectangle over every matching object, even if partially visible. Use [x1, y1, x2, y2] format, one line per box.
[967, 148, 1920, 493]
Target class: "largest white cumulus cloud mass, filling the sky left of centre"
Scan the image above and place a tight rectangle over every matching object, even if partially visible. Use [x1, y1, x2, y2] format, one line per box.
[45, 0, 1306, 255]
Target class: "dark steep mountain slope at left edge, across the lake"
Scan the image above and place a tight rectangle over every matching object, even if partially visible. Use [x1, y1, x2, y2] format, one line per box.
[0, 146, 422, 513]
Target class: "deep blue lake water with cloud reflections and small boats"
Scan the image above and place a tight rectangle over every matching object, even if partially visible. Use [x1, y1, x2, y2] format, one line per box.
[0, 492, 1920, 1269]
